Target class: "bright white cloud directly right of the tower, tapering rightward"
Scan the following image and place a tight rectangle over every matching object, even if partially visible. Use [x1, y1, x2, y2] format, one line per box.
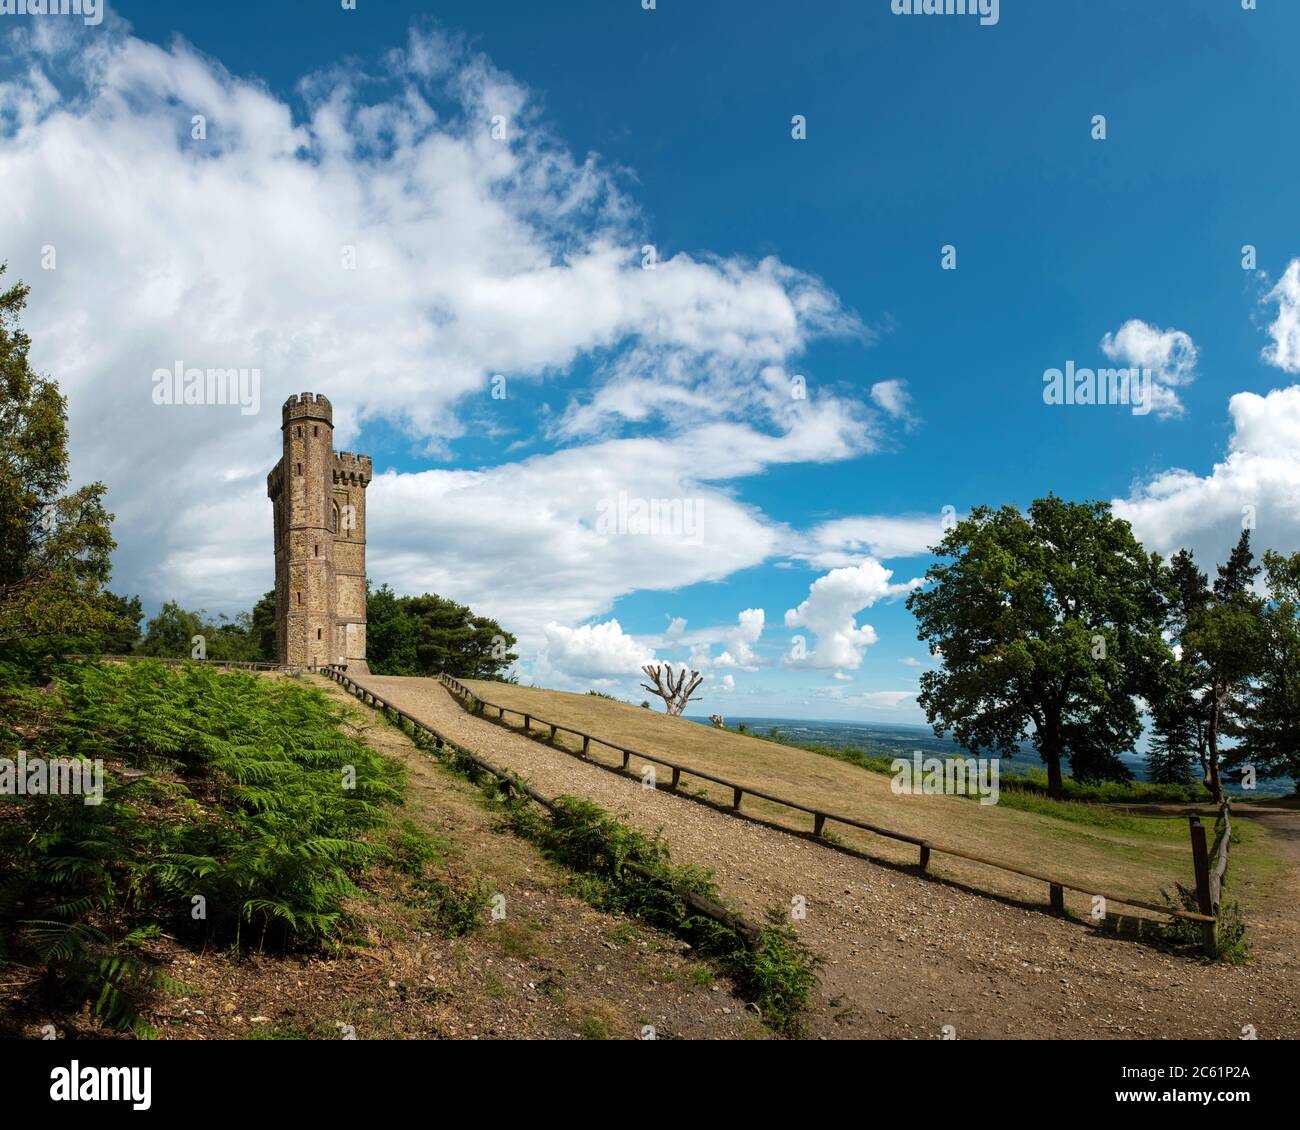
[367, 440, 785, 647]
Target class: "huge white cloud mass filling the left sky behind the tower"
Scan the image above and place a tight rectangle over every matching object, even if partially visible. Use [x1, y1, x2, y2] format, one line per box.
[0, 17, 885, 639]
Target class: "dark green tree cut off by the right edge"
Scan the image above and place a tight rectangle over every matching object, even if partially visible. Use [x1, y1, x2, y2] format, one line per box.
[1225, 551, 1300, 791]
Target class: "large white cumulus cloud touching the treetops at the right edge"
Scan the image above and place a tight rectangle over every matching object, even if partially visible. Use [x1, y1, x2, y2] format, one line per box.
[1114, 385, 1300, 568]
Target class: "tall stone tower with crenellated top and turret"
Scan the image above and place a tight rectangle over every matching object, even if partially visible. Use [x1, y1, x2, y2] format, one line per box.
[267, 393, 371, 671]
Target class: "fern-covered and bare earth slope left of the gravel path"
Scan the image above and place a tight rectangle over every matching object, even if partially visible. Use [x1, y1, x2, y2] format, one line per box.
[0, 661, 780, 1040]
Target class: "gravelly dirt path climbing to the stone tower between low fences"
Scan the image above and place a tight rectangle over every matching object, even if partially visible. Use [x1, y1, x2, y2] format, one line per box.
[343, 676, 1300, 1039]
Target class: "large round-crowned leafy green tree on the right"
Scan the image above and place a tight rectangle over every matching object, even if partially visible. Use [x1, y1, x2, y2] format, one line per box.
[907, 495, 1167, 798]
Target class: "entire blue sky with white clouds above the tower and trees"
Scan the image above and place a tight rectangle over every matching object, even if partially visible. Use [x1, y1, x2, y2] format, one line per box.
[0, 0, 1300, 722]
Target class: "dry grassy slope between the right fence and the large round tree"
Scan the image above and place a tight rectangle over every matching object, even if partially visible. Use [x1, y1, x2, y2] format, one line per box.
[467, 681, 1286, 913]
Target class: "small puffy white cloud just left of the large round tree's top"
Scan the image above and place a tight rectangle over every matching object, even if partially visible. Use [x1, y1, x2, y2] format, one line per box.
[785, 558, 920, 670]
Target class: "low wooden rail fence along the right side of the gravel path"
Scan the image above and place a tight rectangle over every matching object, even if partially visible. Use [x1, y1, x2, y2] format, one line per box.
[428, 674, 1226, 928]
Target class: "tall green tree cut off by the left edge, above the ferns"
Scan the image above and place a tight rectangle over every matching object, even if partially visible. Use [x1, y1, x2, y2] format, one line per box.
[0, 264, 118, 644]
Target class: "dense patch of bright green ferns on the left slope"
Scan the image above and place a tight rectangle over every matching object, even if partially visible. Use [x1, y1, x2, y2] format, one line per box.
[0, 657, 403, 1035]
